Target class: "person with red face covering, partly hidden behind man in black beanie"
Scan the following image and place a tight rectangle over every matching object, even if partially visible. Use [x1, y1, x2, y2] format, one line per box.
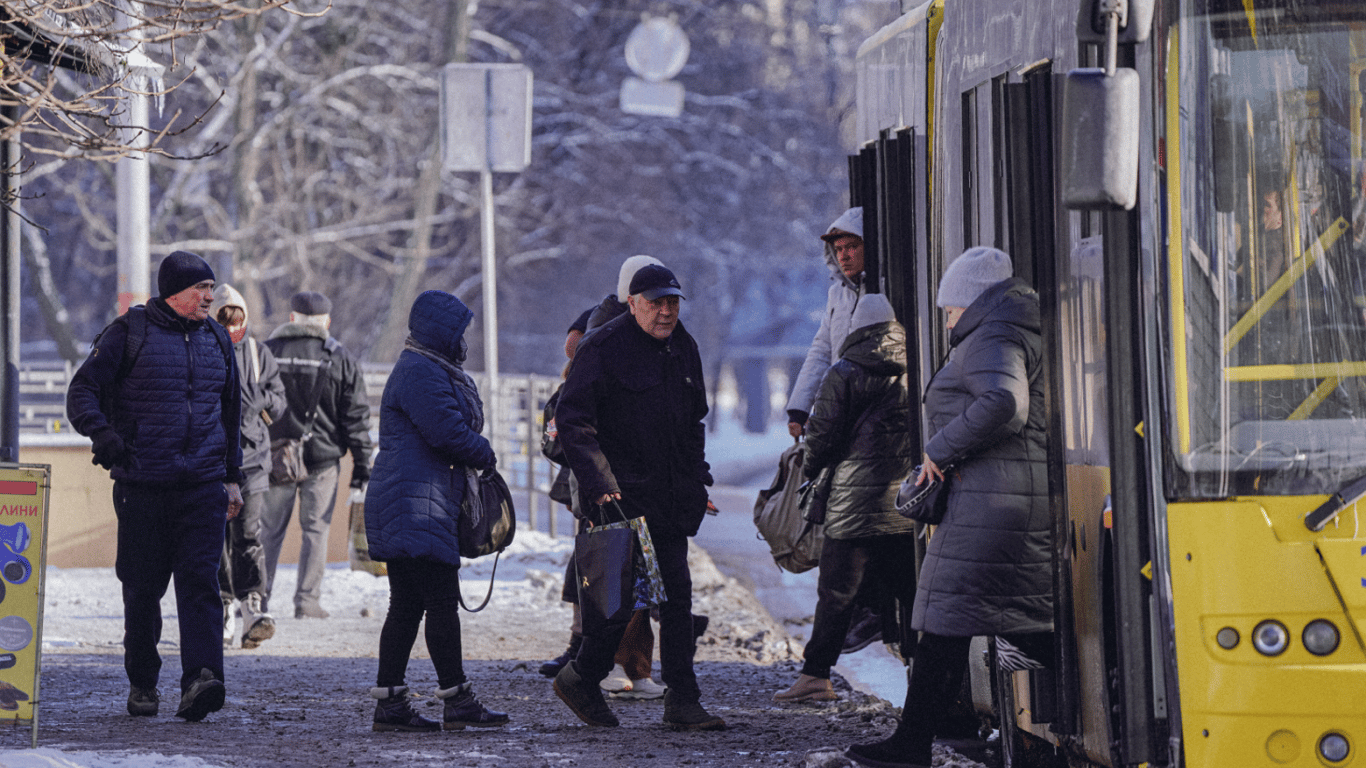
[209, 283, 285, 648]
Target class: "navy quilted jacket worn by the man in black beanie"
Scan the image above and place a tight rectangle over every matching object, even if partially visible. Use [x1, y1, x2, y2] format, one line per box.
[67, 299, 242, 486]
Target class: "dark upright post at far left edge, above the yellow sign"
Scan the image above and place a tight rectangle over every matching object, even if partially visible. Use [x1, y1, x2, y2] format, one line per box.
[0, 104, 20, 462]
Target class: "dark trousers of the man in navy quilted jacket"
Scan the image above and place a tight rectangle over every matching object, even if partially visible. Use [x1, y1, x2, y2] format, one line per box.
[113, 482, 228, 691]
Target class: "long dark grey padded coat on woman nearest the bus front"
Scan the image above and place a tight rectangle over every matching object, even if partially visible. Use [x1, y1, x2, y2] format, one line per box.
[911, 277, 1053, 637]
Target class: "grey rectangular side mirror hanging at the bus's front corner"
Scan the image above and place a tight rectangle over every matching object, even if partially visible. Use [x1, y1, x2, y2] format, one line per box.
[1063, 68, 1139, 210]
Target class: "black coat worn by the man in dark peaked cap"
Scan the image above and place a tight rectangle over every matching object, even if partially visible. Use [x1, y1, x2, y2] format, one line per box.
[555, 307, 712, 536]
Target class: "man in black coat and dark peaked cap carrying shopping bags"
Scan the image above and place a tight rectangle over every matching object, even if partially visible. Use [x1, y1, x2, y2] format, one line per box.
[553, 264, 725, 730]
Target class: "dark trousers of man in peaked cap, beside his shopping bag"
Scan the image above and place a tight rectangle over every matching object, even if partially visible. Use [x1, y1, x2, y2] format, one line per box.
[574, 532, 701, 700]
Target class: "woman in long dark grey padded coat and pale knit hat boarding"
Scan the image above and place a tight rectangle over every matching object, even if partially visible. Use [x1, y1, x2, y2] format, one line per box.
[846, 246, 1053, 767]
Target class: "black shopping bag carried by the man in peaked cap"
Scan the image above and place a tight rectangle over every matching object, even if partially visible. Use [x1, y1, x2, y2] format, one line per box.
[574, 516, 637, 625]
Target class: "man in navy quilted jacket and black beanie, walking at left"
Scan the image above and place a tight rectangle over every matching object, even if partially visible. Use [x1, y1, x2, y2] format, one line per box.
[67, 250, 242, 720]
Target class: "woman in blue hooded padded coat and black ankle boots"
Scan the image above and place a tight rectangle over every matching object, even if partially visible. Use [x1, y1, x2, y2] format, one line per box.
[365, 291, 508, 731]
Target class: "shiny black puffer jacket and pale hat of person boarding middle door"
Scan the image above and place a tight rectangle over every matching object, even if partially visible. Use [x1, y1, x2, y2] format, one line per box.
[802, 297, 917, 538]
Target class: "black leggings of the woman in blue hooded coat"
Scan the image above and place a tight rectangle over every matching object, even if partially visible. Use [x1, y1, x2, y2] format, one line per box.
[376, 558, 466, 689]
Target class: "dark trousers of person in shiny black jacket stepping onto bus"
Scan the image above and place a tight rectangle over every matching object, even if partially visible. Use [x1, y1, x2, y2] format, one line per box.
[802, 533, 915, 679]
